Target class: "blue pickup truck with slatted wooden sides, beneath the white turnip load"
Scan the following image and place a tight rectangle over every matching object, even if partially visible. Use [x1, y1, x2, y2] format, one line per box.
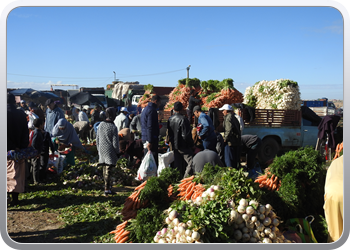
[243, 109, 318, 162]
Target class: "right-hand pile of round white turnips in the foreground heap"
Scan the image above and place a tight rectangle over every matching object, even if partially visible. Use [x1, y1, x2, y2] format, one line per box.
[229, 199, 292, 243]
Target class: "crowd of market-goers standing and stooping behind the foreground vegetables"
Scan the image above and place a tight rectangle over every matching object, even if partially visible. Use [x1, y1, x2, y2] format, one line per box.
[7, 91, 261, 205]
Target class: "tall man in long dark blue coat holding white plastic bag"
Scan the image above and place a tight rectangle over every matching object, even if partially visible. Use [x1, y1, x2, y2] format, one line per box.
[141, 95, 160, 166]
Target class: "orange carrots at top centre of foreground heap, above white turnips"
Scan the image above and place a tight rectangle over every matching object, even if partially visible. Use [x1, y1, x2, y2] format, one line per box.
[177, 175, 205, 201]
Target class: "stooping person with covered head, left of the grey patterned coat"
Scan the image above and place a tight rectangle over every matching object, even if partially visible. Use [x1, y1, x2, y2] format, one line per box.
[51, 118, 87, 169]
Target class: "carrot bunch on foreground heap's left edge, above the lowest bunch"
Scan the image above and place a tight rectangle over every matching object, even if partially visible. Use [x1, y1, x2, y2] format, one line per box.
[122, 181, 148, 221]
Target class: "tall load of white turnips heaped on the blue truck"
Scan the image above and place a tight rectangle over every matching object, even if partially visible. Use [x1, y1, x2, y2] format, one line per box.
[243, 79, 302, 110]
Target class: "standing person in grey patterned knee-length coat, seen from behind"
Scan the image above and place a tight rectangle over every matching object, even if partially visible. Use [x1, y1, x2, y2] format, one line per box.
[96, 107, 119, 196]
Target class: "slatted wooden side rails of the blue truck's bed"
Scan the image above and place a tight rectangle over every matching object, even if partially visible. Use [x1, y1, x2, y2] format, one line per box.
[243, 109, 301, 127]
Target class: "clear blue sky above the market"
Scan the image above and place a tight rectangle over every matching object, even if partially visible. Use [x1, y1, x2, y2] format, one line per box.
[6, 7, 344, 99]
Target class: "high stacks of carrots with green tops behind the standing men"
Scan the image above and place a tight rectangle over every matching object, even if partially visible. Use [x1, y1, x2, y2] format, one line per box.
[164, 78, 243, 111]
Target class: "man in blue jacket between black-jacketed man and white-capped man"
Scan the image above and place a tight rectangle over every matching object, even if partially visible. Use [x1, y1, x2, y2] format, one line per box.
[193, 106, 217, 152]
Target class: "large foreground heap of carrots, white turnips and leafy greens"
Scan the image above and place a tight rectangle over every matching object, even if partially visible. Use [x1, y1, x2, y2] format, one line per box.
[110, 164, 312, 243]
